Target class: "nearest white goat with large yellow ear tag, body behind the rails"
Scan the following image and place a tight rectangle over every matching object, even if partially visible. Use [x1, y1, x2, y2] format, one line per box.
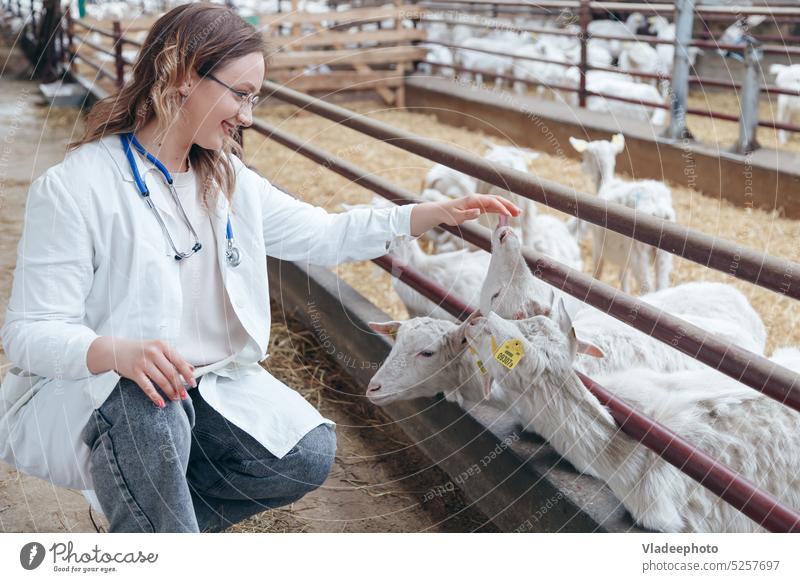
[465, 304, 800, 532]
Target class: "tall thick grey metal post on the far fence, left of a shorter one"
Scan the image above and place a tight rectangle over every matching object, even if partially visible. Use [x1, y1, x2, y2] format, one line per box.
[667, 0, 695, 139]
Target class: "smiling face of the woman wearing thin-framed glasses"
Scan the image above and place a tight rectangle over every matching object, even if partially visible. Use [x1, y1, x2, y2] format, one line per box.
[180, 52, 264, 150]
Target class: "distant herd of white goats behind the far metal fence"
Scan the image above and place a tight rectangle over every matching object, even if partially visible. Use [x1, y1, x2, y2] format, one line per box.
[420, 12, 800, 144]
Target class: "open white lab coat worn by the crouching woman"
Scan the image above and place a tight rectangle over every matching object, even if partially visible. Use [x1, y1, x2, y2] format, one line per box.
[0, 135, 414, 490]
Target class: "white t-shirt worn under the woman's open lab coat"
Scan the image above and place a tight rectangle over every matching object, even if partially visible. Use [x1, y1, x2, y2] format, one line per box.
[144, 157, 247, 367]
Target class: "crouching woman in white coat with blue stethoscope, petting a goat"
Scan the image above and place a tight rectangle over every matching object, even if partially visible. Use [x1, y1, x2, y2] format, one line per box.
[0, 3, 519, 532]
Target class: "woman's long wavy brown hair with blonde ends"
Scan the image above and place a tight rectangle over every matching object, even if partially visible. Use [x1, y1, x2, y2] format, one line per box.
[69, 3, 268, 212]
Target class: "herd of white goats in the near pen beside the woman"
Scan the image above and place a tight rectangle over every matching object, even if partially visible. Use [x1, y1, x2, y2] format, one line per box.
[356, 134, 800, 532]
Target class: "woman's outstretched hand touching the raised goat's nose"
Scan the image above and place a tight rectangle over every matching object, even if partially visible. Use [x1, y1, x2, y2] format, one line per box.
[411, 194, 522, 236]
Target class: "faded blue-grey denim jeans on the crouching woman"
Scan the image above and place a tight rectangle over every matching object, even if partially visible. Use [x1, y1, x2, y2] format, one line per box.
[81, 378, 336, 532]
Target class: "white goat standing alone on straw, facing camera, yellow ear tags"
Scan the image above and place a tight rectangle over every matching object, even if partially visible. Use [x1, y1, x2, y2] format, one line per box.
[569, 133, 675, 293]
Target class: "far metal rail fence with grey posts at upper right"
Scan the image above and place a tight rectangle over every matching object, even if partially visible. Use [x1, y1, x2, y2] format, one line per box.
[420, 0, 800, 153]
